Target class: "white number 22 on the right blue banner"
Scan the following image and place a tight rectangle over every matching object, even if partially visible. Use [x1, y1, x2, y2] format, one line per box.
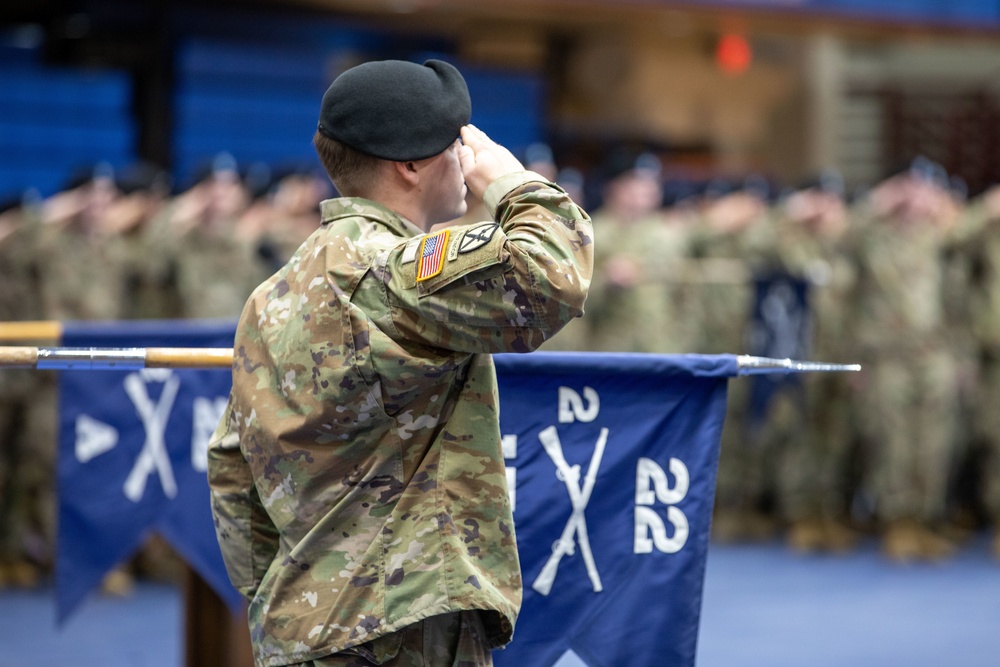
[632, 457, 691, 554]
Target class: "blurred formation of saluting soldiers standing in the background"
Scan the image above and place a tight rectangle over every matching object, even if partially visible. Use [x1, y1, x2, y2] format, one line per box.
[0, 147, 1000, 590]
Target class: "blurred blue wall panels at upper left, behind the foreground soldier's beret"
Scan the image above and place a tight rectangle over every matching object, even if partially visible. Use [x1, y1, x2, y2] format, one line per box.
[0, 10, 546, 199]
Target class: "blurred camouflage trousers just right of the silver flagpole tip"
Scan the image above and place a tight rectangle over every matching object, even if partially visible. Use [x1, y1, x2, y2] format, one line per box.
[860, 350, 958, 523]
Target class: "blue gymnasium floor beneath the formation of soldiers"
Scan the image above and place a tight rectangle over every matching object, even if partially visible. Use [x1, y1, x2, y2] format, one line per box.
[0, 536, 1000, 667]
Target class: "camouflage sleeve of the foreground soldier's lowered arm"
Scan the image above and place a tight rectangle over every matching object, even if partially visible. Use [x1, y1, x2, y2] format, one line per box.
[208, 399, 278, 599]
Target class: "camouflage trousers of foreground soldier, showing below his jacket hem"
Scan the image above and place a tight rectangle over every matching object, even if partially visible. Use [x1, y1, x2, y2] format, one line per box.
[290, 611, 493, 667]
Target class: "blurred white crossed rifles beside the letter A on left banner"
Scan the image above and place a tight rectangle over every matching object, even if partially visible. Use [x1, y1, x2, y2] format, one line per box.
[123, 369, 181, 503]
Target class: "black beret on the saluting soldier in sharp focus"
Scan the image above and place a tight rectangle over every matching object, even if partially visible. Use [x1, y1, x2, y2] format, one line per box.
[318, 60, 472, 161]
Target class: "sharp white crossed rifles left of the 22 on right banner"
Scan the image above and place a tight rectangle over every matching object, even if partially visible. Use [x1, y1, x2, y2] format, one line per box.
[531, 426, 608, 595]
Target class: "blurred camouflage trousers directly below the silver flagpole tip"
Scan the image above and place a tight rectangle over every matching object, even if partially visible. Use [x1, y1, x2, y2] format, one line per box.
[777, 373, 854, 521]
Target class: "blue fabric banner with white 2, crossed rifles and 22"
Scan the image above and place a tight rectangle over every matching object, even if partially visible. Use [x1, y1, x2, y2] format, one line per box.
[494, 354, 737, 667]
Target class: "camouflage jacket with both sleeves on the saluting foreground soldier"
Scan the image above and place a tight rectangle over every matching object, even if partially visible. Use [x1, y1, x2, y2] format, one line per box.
[209, 172, 593, 665]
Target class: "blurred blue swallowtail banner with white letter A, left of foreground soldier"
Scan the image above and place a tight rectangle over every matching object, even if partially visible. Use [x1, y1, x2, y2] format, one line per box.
[56, 322, 241, 621]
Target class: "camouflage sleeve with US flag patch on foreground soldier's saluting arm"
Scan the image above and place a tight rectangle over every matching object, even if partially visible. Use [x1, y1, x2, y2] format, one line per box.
[373, 172, 593, 353]
